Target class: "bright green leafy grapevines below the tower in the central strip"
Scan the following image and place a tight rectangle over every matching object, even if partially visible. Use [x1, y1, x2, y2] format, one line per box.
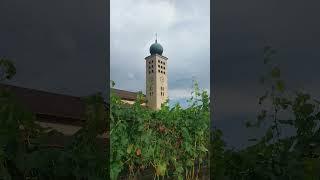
[110, 83, 210, 179]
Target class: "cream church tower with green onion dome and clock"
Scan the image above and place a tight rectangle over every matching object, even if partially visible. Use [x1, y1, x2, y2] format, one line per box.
[145, 38, 168, 110]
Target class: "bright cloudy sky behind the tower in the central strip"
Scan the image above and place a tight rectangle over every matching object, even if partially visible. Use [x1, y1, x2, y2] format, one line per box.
[110, 0, 210, 105]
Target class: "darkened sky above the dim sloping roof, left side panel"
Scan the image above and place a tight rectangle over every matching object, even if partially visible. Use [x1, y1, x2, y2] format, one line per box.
[0, 0, 108, 96]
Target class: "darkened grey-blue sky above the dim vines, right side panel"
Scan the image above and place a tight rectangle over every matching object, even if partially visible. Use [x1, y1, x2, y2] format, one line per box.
[213, 0, 320, 148]
